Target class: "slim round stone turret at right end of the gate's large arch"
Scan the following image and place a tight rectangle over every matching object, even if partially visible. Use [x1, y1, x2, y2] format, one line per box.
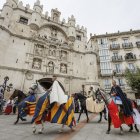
[68, 15, 76, 42]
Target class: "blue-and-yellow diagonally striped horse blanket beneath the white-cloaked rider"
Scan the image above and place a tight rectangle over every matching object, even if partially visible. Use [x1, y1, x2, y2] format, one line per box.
[32, 93, 75, 127]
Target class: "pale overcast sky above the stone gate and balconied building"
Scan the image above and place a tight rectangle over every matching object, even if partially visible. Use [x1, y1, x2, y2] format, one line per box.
[0, 0, 140, 35]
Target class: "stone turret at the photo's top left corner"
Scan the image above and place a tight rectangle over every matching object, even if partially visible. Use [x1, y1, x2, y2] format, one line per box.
[1, 0, 18, 26]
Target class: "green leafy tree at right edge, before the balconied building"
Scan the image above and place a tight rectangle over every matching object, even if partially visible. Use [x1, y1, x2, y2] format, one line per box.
[124, 67, 140, 96]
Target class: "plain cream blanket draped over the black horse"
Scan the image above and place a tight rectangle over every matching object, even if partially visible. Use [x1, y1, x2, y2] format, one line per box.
[86, 97, 105, 113]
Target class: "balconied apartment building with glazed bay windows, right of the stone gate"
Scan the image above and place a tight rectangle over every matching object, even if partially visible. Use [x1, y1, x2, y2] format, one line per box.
[88, 30, 140, 96]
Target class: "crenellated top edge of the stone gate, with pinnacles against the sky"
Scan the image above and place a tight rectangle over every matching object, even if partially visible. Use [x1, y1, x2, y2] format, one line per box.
[0, 0, 87, 34]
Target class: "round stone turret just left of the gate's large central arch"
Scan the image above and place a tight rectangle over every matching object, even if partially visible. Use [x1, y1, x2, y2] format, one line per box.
[29, 0, 43, 30]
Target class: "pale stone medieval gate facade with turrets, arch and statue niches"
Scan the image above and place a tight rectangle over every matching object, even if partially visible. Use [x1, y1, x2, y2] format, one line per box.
[0, 0, 99, 94]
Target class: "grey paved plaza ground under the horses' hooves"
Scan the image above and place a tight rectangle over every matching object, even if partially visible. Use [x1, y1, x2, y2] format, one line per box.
[0, 114, 140, 140]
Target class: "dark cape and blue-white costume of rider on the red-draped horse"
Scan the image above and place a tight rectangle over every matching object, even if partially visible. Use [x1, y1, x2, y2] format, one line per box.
[110, 85, 132, 116]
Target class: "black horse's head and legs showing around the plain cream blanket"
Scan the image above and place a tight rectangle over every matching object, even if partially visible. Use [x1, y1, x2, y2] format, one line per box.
[74, 93, 107, 123]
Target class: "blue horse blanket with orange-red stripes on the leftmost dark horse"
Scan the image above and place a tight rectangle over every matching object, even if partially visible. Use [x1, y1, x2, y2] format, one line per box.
[18, 95, 36, 117]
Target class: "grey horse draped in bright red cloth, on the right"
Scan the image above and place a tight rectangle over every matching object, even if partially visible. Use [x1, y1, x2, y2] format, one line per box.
[98, 89, 138, 134]
